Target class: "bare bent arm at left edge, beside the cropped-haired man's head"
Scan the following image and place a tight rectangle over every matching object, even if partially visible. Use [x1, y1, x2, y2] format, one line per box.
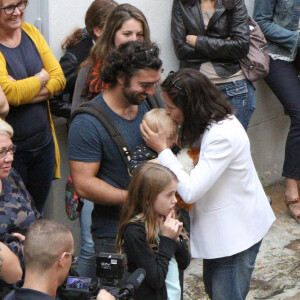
[0, 243, 23, 284]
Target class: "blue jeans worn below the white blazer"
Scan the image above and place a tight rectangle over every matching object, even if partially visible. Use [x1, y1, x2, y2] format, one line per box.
[203, 241, 262, 300]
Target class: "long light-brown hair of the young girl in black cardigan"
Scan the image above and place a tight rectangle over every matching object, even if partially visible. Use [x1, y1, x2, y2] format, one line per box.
[116, 162, 177, 253]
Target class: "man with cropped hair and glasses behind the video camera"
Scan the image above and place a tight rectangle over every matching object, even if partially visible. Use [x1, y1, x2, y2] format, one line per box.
[4, 220, 114, 300]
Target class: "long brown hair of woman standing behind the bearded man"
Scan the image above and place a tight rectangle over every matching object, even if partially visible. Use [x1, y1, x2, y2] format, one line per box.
[88, 3, 150, 64]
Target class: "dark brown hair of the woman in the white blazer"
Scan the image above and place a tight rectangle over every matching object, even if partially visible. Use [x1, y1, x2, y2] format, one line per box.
[162, 69, 233, 146]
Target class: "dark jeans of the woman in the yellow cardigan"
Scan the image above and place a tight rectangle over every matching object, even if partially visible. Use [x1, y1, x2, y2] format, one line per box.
[13, 139, 55, 213]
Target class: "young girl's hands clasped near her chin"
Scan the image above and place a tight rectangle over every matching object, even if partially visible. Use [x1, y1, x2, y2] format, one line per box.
[159, 210, 183, 242]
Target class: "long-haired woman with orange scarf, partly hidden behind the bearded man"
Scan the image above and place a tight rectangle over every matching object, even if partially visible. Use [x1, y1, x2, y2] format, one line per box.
[72, 3, 150, 110]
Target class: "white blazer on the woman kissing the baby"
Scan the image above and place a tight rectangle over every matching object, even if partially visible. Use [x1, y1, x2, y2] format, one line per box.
[158, 116, 275, 259]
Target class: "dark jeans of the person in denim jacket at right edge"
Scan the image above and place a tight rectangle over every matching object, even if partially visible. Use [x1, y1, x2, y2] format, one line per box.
[265, 58, 300, 180]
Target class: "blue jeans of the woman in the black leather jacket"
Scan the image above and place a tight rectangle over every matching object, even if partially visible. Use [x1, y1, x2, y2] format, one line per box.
[217, 79, 255, 131]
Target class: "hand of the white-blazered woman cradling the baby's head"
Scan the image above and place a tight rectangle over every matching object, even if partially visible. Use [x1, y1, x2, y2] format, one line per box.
[140, 120, 168, 153]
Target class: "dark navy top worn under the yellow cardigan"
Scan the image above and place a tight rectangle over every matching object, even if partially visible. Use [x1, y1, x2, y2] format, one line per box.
[0, 31, 52, 151]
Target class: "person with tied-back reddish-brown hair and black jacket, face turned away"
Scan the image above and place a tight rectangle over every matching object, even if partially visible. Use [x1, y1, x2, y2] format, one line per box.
[50, 0, 118, 119]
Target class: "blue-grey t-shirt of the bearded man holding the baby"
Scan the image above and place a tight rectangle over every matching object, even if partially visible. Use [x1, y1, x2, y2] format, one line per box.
[68, 94, 150, 237]
